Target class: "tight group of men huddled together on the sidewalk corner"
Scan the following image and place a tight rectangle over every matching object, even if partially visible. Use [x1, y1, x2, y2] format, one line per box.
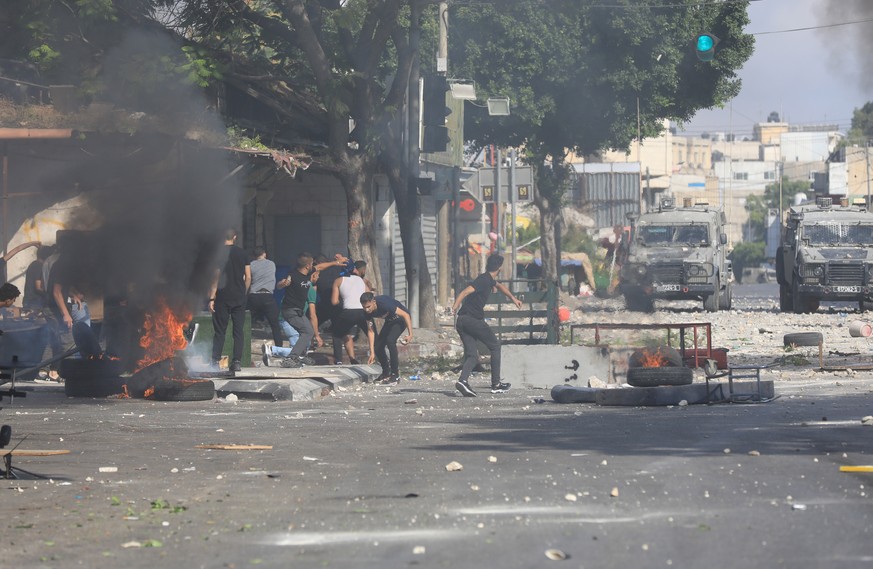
[208, 229, 412, 385]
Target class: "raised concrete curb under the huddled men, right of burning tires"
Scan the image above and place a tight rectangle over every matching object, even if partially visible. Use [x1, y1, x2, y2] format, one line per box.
[213, 365, 382, 401]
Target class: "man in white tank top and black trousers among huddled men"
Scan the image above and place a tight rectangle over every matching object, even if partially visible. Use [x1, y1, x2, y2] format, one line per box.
[330, 261, 376, 365]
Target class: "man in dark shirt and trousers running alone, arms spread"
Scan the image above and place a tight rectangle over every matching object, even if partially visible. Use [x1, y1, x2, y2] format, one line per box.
[452, 255, 521, 397]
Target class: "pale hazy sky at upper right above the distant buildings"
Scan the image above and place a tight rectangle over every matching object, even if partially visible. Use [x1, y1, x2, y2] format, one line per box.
[685, 0, 873, 136]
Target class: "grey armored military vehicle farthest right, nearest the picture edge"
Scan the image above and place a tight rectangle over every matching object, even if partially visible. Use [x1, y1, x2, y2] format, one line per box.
[776, 198, 873, 313]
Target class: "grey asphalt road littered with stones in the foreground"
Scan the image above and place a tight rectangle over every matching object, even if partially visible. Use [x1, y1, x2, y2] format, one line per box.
[0, 360, 873, 569]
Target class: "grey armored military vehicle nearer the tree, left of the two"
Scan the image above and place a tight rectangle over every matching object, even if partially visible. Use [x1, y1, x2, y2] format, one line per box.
[619, 198, 733, 312]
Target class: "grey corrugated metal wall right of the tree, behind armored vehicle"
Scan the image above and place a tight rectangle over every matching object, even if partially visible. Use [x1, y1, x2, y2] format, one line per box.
[573, 172, 640, 228]
